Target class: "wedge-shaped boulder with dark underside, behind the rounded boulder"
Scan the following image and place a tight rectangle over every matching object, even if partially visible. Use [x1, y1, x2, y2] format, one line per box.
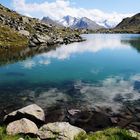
[4, 104, 45, 126]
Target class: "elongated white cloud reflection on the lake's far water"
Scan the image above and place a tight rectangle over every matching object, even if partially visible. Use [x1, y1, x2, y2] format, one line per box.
[22, 35, 129, 69]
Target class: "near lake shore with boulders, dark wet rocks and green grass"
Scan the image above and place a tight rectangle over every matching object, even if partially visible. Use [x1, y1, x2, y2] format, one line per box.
[0, 104, 140, 140]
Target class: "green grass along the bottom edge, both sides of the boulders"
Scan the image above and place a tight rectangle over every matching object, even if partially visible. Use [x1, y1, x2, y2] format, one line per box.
[0, 127, 140, 140]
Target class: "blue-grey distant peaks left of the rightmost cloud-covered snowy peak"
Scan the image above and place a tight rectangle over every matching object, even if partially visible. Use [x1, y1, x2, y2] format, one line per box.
[42, 16, 104, 30]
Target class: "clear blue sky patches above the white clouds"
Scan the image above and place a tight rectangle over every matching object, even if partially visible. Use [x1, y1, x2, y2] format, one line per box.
[0, 0, 140, 13]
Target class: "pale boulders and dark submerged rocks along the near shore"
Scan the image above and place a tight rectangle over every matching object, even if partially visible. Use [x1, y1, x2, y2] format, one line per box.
[0, 104, 140, 140]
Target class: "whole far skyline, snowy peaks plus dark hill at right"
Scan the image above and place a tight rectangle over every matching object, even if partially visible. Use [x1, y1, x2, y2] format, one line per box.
[42, 13, 140, 33]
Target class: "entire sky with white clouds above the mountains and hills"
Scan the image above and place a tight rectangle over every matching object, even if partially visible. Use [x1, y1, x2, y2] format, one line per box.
[0, 0, 140, 25]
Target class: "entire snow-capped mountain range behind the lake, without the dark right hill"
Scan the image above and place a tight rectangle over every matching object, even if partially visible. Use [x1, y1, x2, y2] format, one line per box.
[42, 16, 120, 30]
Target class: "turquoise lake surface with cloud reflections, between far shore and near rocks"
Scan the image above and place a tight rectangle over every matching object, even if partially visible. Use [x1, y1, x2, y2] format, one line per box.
[0, 34, 140, 113]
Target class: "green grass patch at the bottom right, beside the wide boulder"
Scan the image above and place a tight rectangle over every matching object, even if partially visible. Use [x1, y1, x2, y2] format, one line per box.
[75, 128, 139, 140]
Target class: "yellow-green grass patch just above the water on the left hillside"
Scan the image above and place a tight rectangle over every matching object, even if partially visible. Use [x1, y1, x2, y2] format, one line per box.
[0, 24, 28, 49]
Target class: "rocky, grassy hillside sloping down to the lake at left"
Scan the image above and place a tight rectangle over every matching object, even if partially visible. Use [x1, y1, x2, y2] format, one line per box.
[0, 5, 82, 48]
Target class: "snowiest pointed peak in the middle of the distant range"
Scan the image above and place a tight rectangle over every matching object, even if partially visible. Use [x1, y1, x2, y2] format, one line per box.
[58, 16, 79, 27]
